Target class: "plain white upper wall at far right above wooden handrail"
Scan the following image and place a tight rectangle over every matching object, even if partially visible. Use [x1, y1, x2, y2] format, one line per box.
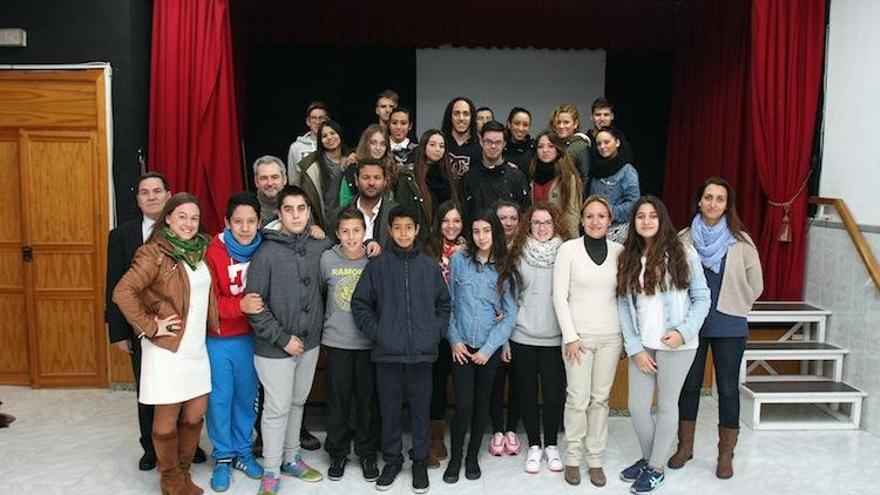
[819, 0, 880, 225]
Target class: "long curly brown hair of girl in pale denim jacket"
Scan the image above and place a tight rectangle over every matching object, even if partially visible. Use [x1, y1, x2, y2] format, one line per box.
[617, 196, 691, 296]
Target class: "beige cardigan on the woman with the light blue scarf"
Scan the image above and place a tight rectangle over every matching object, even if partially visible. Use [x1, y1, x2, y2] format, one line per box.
[678, 228, 764, 318]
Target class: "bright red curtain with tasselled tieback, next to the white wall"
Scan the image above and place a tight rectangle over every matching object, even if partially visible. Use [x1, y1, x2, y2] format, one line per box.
[749, 0, 825, 300]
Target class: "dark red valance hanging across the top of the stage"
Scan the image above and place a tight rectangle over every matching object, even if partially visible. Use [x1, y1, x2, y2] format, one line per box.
[227, 0, 676, 50]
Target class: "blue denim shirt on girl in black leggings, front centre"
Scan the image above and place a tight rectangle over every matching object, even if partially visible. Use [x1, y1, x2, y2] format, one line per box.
[447, 250, 517, 357]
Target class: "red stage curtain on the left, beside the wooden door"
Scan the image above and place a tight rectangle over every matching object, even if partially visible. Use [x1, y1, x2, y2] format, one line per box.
[149, 0, 243, 232]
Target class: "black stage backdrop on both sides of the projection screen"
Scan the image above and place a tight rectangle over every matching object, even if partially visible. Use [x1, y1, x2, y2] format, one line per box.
[243, 45, 673, 195]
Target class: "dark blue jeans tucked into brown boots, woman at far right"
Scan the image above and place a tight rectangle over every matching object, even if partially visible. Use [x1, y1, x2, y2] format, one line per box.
[678, 336, 746, 430]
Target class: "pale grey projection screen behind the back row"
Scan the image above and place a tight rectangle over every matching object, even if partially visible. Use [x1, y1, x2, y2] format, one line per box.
[416, 47, 605, 136]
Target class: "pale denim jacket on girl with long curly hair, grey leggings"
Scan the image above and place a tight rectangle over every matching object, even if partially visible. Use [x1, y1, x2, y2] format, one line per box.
[617, 245, 711, 357]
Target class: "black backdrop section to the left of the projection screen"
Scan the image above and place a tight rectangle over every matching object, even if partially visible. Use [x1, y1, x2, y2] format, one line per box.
[243, 45, 418, 185]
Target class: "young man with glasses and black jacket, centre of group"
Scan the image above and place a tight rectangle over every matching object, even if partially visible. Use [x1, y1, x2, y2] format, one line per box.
[461, 120, 529, 221]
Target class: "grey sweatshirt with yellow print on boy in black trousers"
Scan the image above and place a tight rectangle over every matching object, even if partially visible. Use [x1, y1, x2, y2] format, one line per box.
[321, 245, 373, 350]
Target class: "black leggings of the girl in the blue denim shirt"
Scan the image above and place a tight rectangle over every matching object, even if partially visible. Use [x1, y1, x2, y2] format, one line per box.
[450, 347, 501, 459]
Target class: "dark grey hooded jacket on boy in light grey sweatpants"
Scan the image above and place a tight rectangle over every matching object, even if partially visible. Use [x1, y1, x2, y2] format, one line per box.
[246, 226, 331, 358]
